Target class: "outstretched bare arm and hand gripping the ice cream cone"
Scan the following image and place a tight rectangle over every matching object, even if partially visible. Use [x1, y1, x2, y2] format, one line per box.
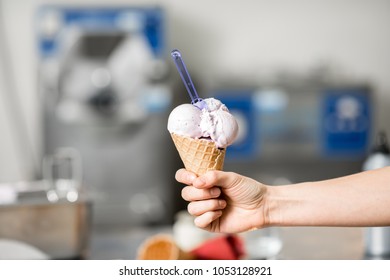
[176, 167, 390, 233]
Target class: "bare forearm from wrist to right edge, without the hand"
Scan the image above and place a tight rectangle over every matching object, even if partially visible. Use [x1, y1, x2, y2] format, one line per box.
[265, 167, 390, 226]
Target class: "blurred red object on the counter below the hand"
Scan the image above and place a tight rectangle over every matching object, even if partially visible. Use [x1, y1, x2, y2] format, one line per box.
[191, 234, 245, 260]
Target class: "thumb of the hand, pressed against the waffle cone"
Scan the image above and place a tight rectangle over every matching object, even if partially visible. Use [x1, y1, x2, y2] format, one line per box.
[192, 170, 242, 189]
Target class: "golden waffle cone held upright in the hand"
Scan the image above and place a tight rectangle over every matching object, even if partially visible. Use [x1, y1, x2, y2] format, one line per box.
[171, 133, 226, 175]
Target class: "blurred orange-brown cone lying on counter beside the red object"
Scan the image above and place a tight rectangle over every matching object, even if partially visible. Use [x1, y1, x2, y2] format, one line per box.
[137, 234, 195, 260]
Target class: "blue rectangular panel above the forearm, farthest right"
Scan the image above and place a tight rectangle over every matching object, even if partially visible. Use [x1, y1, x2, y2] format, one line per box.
[321, 87, 371, 157]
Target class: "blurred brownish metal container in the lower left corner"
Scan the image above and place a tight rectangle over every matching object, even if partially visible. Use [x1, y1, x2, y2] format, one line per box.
[0, 200, 91, 259]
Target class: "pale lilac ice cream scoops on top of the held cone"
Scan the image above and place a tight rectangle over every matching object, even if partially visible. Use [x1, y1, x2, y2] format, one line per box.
[168, 98, 238, 148]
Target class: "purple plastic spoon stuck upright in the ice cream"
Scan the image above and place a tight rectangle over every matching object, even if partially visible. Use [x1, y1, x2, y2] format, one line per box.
[171, 49, 207, 110]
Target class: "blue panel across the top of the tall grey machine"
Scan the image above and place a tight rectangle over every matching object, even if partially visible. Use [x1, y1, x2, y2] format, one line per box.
[38, 6, 165, 57]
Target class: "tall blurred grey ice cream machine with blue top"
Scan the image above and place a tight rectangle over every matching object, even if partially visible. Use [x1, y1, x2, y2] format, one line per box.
[36, 6, 173, 225]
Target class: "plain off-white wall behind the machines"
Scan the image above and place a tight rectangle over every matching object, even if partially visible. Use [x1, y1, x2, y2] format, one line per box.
[0, 0, 390, 181]
